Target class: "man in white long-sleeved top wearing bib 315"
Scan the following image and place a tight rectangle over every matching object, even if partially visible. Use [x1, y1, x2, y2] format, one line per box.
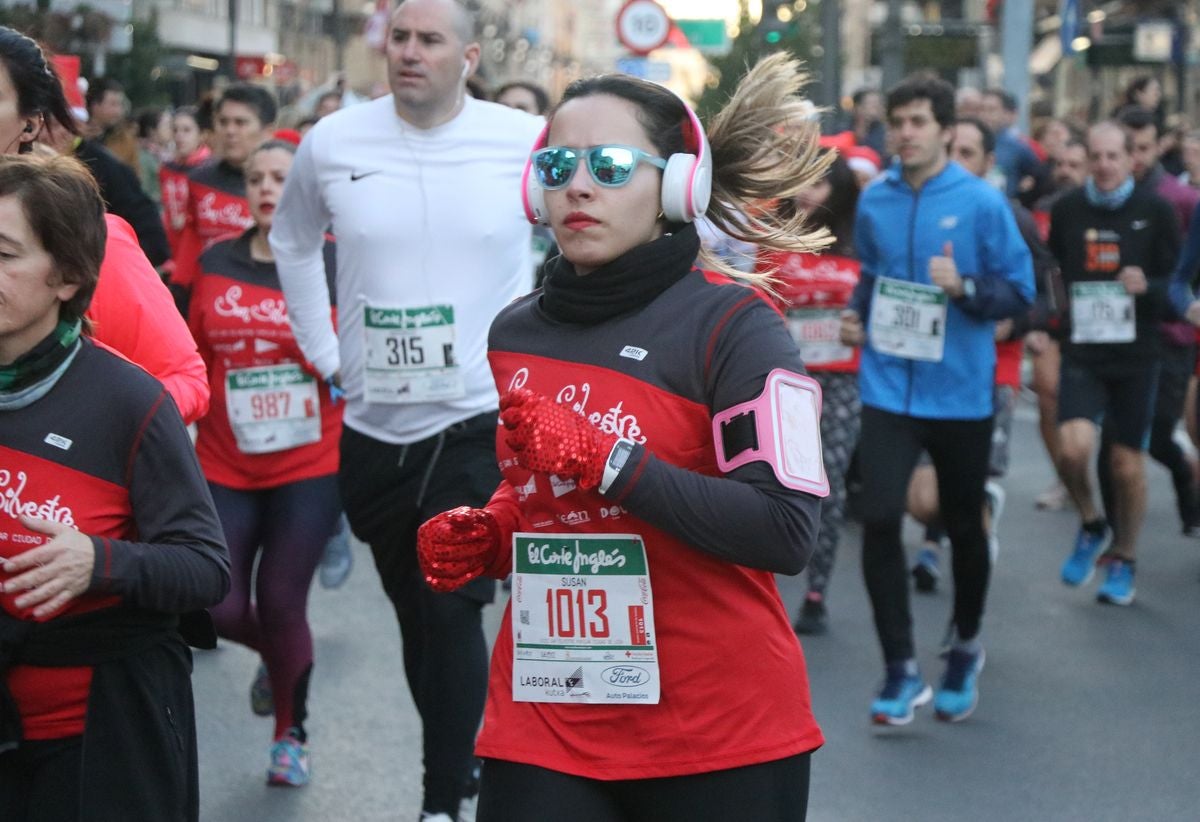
[270, 0, 544, 820]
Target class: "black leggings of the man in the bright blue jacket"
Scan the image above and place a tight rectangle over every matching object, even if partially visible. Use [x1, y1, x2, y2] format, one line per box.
[858, 406, 992, 662]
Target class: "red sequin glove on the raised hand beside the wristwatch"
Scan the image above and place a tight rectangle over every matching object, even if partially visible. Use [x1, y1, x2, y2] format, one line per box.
[500, 389, 618, 488]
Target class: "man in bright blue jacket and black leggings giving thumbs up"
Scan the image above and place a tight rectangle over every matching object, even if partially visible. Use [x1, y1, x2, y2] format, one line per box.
[841, 76, 1034, 725]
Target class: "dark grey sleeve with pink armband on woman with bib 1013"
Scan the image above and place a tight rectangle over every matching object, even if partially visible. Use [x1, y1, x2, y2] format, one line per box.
[605, 296, 821, 575]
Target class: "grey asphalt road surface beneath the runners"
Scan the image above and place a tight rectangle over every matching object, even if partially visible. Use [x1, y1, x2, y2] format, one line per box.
[194, 410, 1200, 822]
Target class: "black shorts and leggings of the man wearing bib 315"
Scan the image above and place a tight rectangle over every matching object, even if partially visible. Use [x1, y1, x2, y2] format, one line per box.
[338, 412, 500, 817]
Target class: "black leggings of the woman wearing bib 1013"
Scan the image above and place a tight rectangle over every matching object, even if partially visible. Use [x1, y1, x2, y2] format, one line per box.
[475, 753, 812, 822]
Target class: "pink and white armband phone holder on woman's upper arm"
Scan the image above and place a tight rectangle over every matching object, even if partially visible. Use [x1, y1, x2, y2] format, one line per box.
[713, 368, 829, 497]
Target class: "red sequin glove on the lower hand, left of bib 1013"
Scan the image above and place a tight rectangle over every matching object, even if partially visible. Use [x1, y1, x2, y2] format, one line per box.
[416, 505, 502, 593]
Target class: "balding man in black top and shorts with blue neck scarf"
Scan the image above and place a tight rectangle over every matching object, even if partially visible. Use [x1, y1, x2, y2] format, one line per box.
[1049, 122, 1180, 605]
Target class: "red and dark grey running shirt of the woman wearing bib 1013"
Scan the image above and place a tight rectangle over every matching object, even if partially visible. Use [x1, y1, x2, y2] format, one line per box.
[476, 270, 823, 780]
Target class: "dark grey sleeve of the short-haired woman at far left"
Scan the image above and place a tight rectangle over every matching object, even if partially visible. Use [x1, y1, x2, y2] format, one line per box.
[89, 391, 229, 613]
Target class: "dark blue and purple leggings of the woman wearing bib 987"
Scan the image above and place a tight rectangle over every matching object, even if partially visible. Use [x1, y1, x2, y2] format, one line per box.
[209, 474, 341, 738]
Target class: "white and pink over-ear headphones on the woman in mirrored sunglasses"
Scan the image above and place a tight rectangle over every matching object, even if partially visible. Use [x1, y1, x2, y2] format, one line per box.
[521, 89, 713, 226]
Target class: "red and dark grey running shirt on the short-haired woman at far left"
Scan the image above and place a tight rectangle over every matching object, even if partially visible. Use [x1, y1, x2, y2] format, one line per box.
[0, 340, 229, 739]
